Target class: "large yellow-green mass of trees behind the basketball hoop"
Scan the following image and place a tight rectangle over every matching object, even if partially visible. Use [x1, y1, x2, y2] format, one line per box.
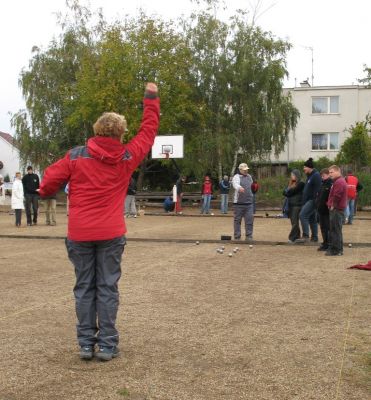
[12, 0, 298, 186]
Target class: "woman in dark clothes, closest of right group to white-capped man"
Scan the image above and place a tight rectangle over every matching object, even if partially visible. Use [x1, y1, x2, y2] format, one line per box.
[283, 169, 305, 243]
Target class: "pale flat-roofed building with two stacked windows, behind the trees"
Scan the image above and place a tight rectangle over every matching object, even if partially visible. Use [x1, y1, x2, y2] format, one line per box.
[271, 82, 371, 163]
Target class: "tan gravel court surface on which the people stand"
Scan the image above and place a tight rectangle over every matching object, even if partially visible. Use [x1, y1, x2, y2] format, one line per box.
[0, 212, 371, 400]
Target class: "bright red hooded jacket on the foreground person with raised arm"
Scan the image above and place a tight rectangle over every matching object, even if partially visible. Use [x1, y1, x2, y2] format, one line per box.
[40, 99, 160, 241]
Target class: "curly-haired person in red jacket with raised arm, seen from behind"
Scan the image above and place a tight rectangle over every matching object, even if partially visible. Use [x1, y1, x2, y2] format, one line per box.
[39, 83, 160, 361]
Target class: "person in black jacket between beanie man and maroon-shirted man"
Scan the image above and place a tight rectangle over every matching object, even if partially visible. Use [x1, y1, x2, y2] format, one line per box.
[316, 168, 332, 251]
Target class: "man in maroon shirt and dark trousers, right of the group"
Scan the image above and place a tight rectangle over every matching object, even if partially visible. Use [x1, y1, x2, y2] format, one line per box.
[326, 165, 348, 256]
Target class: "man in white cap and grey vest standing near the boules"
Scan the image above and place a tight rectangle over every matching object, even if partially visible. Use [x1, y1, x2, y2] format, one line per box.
[232, 163, 254, 241]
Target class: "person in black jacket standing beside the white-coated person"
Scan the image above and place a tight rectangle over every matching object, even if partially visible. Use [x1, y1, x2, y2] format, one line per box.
[22, 165, 40, 226]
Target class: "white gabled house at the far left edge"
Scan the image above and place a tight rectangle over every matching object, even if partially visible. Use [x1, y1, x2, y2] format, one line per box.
[0, 132, 21, 182]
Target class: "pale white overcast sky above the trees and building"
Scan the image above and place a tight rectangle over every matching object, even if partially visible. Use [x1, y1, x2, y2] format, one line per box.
[0, 0, 371, 134]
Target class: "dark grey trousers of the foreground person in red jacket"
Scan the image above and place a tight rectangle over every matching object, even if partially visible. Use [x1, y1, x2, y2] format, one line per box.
[66, 236, 126, 347]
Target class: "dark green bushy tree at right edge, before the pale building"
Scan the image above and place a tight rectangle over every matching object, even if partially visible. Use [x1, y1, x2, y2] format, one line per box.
[335, 115, 371, 171]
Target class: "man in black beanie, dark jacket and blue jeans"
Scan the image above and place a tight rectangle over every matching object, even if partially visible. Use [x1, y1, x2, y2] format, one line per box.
[296, 158, 322, 243]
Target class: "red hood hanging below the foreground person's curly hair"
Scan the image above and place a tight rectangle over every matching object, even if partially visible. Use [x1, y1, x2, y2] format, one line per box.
[88, 136, 125, 164]
